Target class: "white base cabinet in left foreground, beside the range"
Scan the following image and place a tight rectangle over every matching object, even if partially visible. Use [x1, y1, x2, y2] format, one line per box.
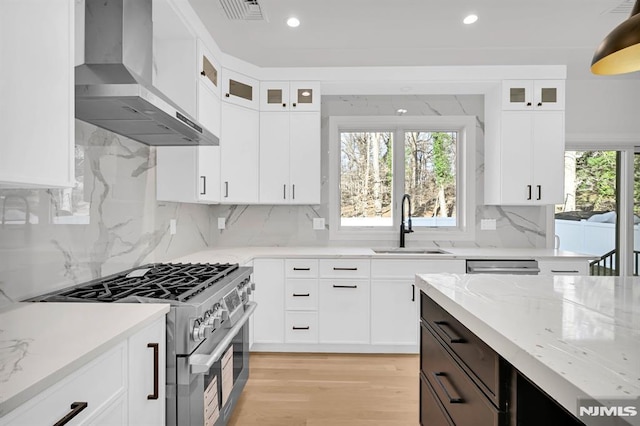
[0, 316, 166, 426]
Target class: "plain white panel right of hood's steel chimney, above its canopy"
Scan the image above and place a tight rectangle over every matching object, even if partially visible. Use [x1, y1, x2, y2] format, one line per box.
[152, 0, 198, 117]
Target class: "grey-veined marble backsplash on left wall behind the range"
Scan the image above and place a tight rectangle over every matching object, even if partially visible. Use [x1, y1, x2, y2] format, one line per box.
[0, 120, 210, 305]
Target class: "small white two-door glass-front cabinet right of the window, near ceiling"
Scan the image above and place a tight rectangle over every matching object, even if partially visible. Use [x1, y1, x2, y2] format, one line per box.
[502, 80, 565, 111]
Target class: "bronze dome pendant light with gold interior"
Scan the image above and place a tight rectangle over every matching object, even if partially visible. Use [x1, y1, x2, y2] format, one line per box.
[591, 0, 640, 75]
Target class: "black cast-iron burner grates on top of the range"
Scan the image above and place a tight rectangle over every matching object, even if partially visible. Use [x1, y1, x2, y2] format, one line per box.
[54, 263, 238, 302]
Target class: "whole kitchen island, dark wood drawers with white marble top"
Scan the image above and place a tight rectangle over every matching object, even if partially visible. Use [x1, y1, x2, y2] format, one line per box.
[416, 274, 640, 425]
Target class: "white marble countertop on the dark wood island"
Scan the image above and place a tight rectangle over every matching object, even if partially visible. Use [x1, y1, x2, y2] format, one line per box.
[416, 274, 640, 424]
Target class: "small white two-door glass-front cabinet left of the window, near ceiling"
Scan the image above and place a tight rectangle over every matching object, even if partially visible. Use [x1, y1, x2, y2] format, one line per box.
[260, 81, 320, 111]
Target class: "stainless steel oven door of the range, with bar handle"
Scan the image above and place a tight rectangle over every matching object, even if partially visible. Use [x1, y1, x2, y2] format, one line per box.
[175, 302, 257, 426]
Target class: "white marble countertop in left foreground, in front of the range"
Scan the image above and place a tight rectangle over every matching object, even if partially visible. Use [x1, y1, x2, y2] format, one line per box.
[0, 303, 169, 417]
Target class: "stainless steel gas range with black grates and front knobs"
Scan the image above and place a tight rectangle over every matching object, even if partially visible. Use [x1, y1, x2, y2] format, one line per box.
[33, 263, 257, 426]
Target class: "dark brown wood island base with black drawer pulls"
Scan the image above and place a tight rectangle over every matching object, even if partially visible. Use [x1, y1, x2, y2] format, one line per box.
[420, 292, 584, 426]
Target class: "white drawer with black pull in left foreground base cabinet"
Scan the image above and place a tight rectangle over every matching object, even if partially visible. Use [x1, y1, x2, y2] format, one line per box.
[0, 342, 127, 425]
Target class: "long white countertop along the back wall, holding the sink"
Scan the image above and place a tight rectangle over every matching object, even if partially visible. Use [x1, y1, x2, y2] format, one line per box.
[169, 247, 597, 264]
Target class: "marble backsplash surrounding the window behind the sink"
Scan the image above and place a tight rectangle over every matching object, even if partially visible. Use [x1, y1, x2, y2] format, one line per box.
[211, 95, 546, 248]
